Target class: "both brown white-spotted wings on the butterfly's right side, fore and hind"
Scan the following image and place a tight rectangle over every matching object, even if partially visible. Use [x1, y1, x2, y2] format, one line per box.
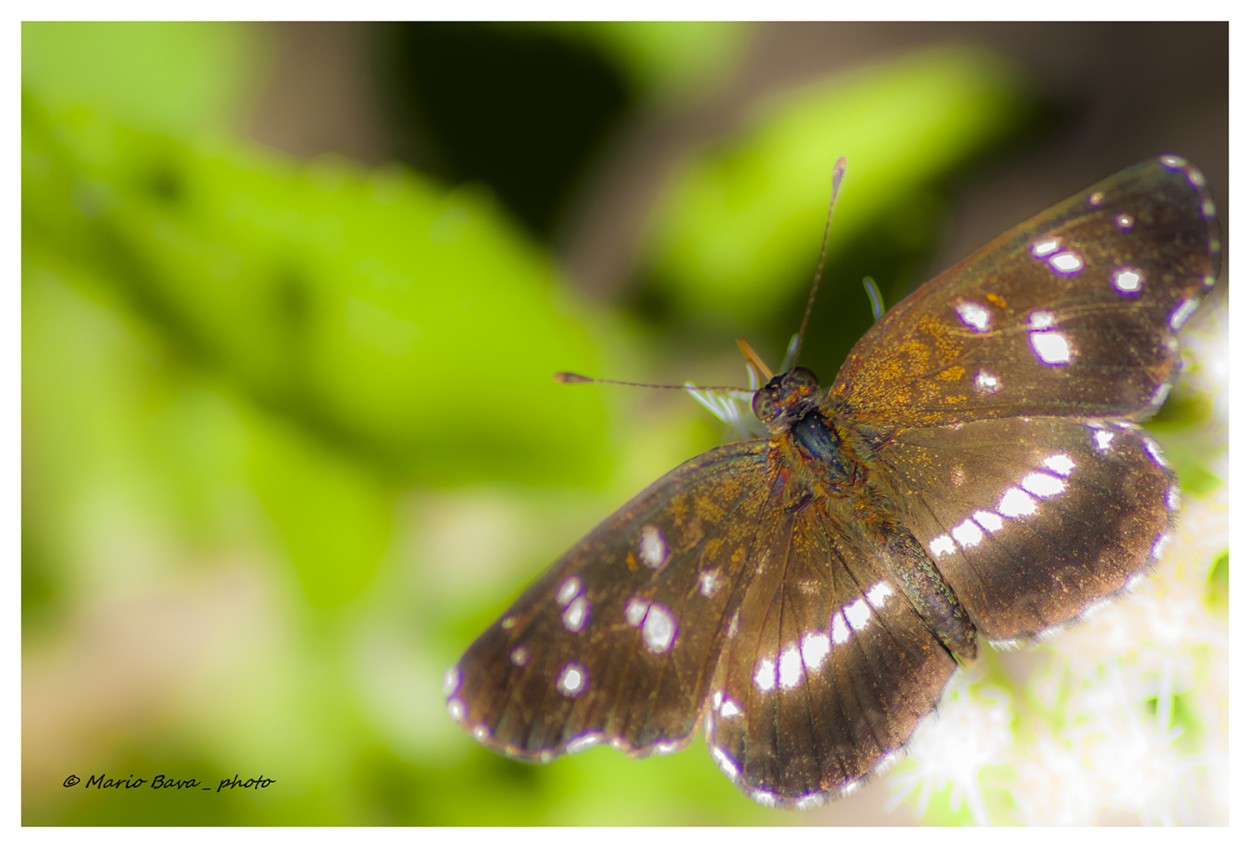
[831, 156, 1219, 640]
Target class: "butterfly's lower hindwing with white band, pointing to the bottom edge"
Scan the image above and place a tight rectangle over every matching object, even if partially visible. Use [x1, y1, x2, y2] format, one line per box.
[708, 487, 956, 808]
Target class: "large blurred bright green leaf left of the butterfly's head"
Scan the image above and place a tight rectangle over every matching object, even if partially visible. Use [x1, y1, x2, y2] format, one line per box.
[23, 86, 615, 492]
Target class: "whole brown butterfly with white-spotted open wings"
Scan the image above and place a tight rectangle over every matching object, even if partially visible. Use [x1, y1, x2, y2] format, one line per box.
[445, 155, 1220, 808]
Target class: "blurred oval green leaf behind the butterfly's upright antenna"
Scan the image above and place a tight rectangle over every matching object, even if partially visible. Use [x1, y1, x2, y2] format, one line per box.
[651, 48, 1034, 323]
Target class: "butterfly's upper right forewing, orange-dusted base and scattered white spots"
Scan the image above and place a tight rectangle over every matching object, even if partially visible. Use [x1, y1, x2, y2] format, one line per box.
[830, 156, 1220, 427]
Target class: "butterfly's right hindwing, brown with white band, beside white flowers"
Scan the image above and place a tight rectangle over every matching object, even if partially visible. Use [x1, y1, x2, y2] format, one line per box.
[876, 418, 1178, 640]
